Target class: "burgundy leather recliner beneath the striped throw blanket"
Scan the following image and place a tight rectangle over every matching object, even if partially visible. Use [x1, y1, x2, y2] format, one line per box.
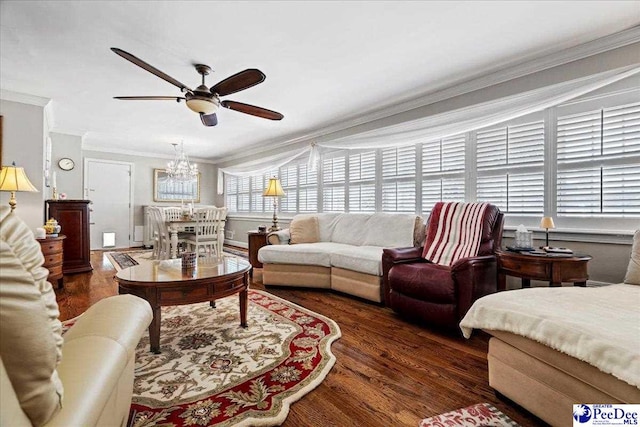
[382, 205, 504, 329]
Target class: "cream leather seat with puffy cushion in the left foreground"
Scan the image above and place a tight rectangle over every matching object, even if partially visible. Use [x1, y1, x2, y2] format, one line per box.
[0, 207, 152, 427]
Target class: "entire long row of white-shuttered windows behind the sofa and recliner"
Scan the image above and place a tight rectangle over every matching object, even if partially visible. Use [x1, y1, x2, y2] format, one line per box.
[225, 79, 640, 234]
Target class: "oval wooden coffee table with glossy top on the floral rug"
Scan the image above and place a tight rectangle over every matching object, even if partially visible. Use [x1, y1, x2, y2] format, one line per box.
[115, 256, 251, 353]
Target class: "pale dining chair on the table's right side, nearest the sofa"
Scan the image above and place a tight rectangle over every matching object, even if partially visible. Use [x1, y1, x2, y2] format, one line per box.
[185, 208, 227, 257]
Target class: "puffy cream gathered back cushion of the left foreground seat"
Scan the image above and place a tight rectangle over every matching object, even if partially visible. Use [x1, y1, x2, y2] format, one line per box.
[0, 206, 63, 425]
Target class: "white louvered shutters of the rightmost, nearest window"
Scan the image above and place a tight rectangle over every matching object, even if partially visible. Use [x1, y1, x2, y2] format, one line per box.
[557, 102, 640, 217]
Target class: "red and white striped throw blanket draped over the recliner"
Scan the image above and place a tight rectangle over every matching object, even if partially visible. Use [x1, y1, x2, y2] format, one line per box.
[423, 202, 489, 265]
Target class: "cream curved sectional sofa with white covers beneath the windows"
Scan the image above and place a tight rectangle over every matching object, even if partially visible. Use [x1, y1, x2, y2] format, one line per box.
[258, 213, 424, 302]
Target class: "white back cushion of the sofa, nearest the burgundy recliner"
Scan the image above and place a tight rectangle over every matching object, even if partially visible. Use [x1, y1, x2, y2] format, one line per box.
[362, 213, 422, 248]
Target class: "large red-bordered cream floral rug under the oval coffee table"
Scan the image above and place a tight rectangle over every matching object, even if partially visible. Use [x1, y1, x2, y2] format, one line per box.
[128, 290, 341, 427]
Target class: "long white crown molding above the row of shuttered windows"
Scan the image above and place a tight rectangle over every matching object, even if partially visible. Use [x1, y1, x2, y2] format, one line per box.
[214, 26, 640, 164]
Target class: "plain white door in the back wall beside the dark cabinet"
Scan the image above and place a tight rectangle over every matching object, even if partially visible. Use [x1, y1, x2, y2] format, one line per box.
[84, 159, 133, 250]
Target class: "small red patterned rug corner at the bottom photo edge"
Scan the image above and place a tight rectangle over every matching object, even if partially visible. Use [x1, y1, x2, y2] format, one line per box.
[420, 403, 518, 427]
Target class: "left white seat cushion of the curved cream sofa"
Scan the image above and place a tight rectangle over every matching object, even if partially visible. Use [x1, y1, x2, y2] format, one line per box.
[258, 242, 347, 267]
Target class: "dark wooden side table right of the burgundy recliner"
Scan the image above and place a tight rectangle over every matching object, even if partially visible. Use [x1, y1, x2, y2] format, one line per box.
[496, 251, 591, 291]
